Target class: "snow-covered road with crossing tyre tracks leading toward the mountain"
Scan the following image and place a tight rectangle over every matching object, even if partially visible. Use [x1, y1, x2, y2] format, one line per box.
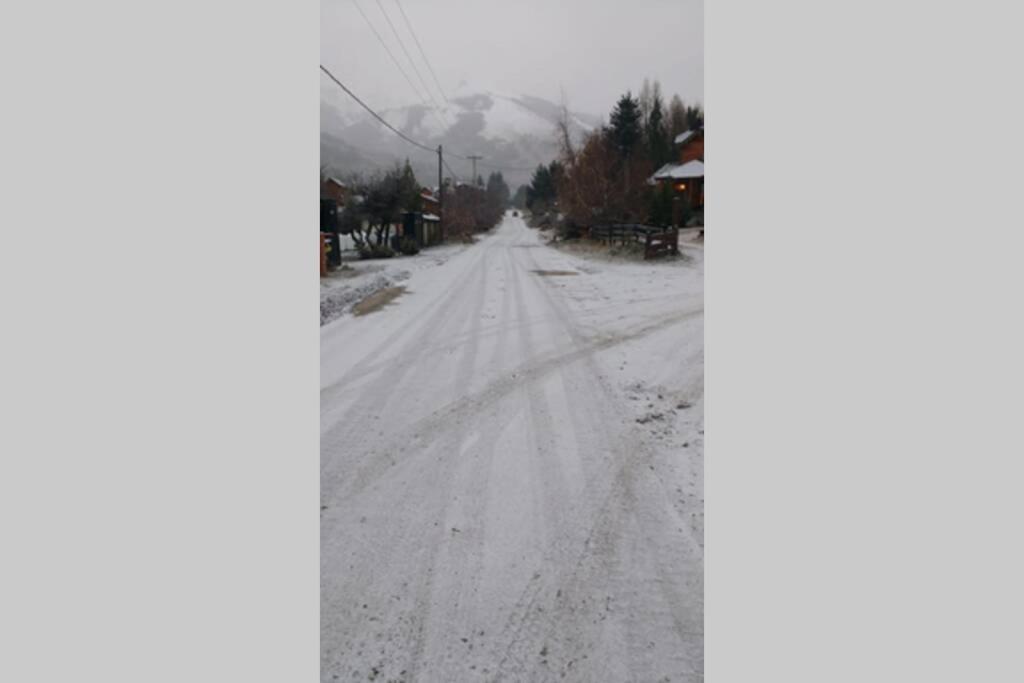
[321, 215, 703, 682]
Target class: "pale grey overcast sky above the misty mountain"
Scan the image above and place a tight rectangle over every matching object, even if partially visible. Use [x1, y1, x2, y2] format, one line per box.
[321, 0, 703, 117]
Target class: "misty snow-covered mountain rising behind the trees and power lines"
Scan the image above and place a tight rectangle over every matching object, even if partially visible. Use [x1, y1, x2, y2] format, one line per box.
[321, 87, 600, 189]
